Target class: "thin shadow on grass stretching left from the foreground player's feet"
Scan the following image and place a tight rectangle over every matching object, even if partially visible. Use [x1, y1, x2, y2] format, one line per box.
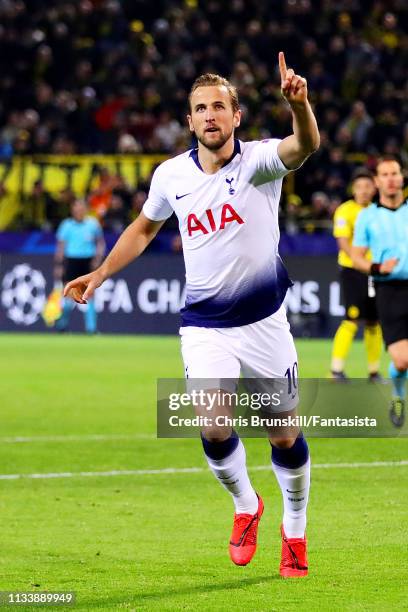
[82, 574, 282, 608]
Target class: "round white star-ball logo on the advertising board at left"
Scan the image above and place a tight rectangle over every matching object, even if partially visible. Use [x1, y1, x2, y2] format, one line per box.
[1, 263, 46, 326]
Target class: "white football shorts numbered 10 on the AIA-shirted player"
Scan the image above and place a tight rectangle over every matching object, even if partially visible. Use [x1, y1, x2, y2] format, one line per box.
[180, 305, 298, 411]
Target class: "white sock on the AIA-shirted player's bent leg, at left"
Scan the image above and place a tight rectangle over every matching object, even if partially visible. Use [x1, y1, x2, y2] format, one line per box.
[206, 440, 258, 514]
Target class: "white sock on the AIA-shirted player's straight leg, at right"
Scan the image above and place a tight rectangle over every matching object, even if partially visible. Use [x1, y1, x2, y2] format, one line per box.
[272, 457, 310, 538]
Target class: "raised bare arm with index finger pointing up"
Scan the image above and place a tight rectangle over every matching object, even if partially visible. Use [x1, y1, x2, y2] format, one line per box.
[278, 51, 320, 170]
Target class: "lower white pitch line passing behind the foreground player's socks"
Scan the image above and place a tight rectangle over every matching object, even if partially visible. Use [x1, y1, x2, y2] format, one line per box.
[0, 460, 408, 480]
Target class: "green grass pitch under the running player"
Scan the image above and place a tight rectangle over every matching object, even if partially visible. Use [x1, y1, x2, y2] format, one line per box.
[0, 334, 408, 612]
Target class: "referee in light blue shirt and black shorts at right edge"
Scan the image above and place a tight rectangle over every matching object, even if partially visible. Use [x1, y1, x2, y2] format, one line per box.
[352, 157, 408, 427]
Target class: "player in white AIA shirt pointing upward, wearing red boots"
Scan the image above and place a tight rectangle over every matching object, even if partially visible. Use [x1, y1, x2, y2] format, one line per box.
[65, 53, 320, 577]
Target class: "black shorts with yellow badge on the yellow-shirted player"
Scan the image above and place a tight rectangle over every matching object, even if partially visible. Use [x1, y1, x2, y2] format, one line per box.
[340, 266, 378, 322]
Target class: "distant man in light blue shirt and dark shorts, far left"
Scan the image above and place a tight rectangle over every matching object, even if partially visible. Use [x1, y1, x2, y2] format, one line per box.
[54, 200, 105, 334]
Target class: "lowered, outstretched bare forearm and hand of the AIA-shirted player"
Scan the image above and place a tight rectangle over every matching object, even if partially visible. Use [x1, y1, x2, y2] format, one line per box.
[64, 212, 164, 304]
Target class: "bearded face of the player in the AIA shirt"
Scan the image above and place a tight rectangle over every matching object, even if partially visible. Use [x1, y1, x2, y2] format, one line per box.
[187, 85, 241, 151]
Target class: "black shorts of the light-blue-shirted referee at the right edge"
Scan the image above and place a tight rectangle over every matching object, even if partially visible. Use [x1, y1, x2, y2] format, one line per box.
[375, 280, 408, 346]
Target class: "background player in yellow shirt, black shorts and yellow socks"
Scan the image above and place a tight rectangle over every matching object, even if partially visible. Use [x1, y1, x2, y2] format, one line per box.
[331, 168, 382, 382]
